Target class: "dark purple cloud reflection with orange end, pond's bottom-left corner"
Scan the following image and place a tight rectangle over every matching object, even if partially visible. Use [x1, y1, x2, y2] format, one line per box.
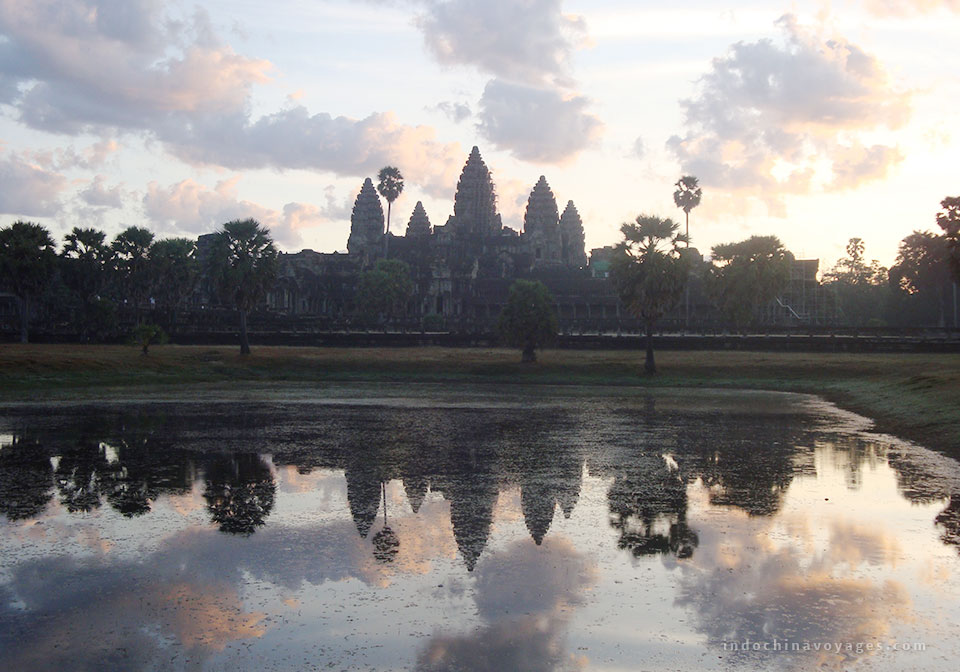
[0, 558, 265, 670]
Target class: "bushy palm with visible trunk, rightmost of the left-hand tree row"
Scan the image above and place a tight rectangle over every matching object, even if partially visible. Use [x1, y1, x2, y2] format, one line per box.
[207, 219, 277, 355]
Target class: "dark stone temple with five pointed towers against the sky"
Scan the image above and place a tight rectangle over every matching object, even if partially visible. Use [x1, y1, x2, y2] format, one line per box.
[258, 147, 618, 328]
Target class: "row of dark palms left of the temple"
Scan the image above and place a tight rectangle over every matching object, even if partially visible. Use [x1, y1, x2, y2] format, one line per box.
[0, 219, 278, 354]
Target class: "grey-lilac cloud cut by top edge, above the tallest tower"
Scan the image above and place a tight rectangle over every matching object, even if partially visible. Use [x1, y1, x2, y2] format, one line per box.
[417, 0, 586, 86]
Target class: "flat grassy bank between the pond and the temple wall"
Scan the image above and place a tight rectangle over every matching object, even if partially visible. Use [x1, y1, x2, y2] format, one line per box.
[0, 345, 960, 457]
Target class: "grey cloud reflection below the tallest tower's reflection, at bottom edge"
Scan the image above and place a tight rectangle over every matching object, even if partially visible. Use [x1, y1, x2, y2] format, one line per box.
[417, 537, 598, 672]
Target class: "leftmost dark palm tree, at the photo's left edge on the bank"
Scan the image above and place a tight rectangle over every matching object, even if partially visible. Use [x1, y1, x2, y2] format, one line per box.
[0, 221, 57, 343]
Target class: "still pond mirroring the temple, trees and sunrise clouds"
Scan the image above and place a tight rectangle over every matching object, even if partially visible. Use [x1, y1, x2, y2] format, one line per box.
[0, 385, 960, 670]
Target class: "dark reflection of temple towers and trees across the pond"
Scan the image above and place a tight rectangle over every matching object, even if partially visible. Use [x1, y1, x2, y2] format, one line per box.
[0, 402, 960, 570]
